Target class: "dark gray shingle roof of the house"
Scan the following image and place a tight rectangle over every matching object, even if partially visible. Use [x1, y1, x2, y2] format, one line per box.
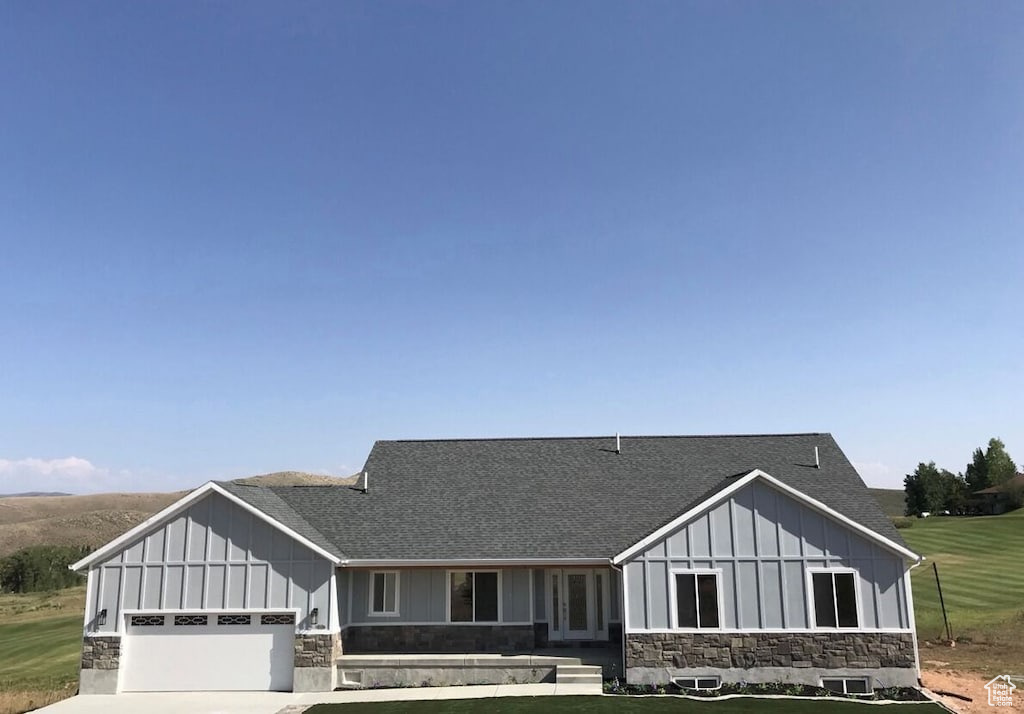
[222, 433, 905, 559]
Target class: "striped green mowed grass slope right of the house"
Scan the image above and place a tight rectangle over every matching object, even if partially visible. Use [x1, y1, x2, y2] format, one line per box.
[900, 509, 1024, 674]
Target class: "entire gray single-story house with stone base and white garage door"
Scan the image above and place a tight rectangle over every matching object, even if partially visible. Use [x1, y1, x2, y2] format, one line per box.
[73, 433, 922, 694]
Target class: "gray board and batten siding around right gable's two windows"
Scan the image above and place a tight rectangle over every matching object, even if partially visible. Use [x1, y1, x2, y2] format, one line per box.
[625, 481, 910, 632]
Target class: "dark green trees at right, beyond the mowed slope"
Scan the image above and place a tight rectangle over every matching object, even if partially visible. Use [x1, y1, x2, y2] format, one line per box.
[903, 438, 1021, 515]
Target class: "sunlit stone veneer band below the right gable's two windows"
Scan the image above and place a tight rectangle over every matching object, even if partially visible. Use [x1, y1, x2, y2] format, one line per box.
[626, 632, 915, 670]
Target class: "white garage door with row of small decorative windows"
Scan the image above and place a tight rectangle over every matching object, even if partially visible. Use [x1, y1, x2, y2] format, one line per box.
[121, 613, 295, 691]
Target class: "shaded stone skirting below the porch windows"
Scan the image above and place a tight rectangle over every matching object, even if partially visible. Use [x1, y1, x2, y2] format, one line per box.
[341, 624, 534, 655]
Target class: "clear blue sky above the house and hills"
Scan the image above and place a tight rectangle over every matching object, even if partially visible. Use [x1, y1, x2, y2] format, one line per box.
[0, 0, 1024, 493]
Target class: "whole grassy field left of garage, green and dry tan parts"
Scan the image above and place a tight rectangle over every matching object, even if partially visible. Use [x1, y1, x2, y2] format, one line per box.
[0, 587, 85, 714]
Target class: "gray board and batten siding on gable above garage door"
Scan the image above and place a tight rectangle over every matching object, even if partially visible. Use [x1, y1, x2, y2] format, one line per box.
[86, 493, 338, 633]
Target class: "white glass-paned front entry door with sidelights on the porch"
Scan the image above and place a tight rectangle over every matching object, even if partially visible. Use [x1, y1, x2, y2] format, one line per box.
[547, 569, 609, 641]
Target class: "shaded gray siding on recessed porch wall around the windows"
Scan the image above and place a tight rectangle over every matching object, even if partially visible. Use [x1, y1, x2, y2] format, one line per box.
[348, 568, 532, 625]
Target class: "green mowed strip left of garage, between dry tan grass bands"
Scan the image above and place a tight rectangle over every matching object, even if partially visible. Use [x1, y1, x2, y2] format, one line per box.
[0, 614, 82, 690]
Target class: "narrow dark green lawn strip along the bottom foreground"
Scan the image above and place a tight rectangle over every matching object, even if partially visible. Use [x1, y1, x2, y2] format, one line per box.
[306, 697, 946, 714]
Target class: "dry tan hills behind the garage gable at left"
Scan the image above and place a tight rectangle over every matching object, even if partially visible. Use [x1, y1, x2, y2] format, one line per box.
[0, 471, 357, 557]
